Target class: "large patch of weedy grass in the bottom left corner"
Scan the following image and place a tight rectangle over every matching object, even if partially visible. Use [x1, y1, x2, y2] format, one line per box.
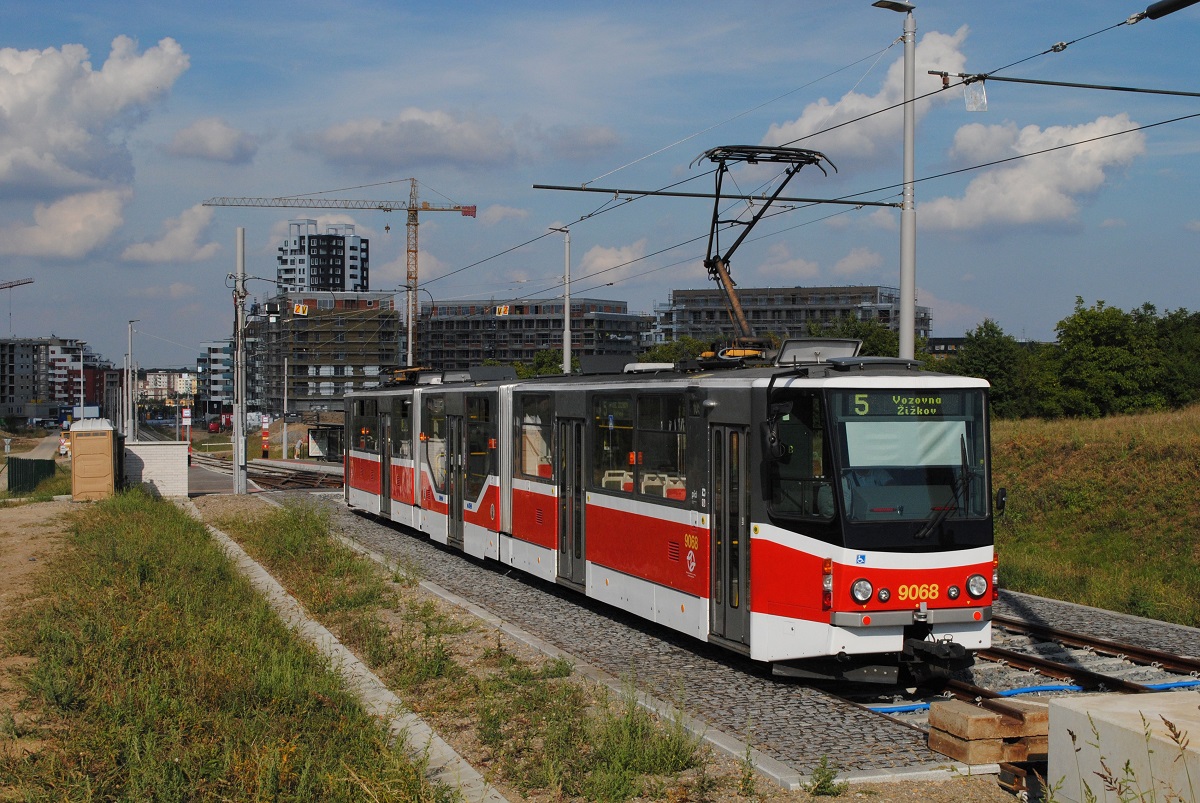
[0, 492, 454, 801]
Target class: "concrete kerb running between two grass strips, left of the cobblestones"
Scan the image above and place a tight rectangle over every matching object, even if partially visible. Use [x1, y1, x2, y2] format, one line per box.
[180, 501, 508, 803]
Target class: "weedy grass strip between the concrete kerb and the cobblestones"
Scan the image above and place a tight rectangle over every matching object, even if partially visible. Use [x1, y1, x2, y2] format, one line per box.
[217, 496, 701, 801]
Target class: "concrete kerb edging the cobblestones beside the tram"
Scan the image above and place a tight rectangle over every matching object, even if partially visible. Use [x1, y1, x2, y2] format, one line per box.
[335, 525, 984, 791]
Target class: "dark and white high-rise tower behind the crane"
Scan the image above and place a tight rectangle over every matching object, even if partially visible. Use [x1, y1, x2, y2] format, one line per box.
[275, 220, 371, 293]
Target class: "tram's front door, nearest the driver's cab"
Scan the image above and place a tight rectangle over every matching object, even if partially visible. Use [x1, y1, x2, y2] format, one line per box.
[709, 426, 750, 645]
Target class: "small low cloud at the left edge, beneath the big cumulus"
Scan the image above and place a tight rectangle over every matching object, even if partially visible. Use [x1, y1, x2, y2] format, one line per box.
[0, 190, 132, 259]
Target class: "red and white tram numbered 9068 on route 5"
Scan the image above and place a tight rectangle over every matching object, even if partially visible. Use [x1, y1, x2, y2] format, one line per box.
[346, 341, 1003, 682]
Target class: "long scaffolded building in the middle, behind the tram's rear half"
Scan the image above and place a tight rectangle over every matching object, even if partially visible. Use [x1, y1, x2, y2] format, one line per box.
[417, 298, 652, 371]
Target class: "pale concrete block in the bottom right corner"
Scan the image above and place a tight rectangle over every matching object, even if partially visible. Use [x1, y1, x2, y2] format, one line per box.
[1046, 691, 1200, 803]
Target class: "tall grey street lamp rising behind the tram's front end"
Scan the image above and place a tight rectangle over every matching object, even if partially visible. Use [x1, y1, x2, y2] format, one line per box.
[871, 0, 917, 360]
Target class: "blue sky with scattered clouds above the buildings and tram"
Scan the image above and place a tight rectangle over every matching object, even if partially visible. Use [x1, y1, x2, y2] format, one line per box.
[0, 0, 1200, 366]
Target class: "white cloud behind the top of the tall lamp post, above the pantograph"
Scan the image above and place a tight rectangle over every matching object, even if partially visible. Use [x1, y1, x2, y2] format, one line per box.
[762, 25, 967, 168]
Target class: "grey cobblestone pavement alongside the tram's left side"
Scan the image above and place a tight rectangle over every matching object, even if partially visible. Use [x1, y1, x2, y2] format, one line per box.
[312, 502, 947, 774]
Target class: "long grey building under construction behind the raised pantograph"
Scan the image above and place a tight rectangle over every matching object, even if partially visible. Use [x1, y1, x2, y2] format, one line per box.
[652, 284, 931, 343]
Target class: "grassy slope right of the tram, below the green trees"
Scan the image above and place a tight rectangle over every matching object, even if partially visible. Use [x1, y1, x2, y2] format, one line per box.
[992, 407, 1200, 627]
